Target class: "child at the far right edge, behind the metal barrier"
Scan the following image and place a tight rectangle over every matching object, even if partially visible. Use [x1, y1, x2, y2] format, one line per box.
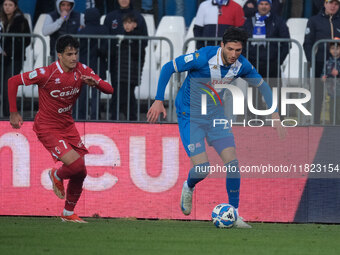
[322, 37, 340, 125]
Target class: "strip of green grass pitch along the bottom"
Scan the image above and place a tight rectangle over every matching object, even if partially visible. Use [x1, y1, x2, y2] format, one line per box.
[0, 217, 340, 255]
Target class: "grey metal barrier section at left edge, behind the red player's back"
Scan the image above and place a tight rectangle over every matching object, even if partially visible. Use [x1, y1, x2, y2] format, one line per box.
[0, 33, 46, 119]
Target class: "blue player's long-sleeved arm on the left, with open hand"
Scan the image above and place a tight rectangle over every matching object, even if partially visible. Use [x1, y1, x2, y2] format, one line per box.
[146, 52, 200, 123]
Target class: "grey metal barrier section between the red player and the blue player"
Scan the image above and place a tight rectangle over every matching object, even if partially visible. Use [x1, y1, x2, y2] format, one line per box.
[69, 35, 175, 122]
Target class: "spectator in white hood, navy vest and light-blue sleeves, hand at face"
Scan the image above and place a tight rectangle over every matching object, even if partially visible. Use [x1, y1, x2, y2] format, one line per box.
[42, 0, 84, 61]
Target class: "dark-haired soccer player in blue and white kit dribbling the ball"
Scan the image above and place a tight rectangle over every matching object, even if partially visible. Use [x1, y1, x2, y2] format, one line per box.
[147, 27, 286, 228]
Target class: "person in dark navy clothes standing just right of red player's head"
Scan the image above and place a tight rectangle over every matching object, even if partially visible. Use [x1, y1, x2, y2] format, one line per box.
[73, 8, 107, 120]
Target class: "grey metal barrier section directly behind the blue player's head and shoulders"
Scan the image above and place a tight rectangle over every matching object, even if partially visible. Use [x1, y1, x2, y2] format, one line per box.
[181, 37, 308, 125]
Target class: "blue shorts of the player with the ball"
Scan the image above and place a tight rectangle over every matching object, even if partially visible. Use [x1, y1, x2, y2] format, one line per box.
[177, 113, 235, 157]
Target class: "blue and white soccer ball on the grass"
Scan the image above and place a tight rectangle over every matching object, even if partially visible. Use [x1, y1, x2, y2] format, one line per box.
[211, 203, 237, 228]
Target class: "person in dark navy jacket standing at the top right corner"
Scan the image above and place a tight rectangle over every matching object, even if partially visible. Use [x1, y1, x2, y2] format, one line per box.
[303, 0, 340, 124]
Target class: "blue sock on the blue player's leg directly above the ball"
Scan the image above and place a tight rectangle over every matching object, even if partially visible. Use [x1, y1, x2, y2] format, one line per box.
[224, 159, 241, 208]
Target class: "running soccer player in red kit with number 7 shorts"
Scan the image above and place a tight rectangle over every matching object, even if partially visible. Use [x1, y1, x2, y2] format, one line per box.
[8, 35, 113, 223]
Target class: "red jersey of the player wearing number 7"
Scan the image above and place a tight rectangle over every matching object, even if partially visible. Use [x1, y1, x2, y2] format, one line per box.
[11, 61, 113, 132]
